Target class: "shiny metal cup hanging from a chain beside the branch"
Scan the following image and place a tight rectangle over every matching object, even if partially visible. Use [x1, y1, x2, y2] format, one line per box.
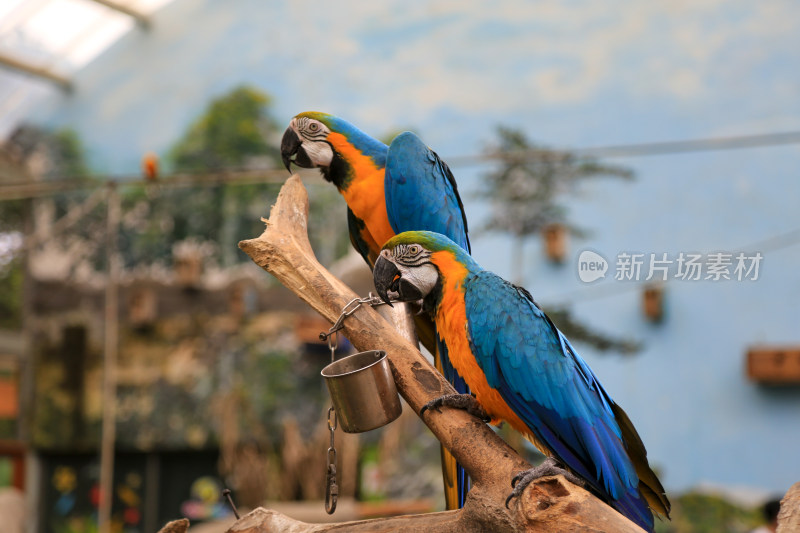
[322, 350, 403, 433]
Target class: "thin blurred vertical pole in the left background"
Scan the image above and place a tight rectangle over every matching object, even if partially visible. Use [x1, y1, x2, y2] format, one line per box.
[97, 183, 120, 533]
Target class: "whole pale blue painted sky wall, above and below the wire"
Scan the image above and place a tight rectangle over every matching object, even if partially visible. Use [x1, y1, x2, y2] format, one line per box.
[7, 0, 800, 493]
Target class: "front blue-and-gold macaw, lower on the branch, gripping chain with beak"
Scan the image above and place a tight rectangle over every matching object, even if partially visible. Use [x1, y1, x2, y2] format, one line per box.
[373, 231, 670, 531]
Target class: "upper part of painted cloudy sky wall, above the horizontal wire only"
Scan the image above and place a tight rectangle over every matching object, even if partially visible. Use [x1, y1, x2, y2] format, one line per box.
[25, 0, 800, 173]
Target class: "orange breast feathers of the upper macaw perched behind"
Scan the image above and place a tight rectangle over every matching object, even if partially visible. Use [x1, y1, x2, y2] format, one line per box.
[328, 132, 394, 253]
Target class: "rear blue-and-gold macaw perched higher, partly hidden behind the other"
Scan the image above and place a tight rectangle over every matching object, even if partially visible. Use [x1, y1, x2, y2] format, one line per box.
[281, 112, 470, 509]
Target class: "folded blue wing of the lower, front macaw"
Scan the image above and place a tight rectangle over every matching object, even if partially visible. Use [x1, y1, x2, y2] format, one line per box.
[465, 271, 653, 530]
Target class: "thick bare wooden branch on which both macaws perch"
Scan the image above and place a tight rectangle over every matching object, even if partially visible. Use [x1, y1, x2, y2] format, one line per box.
[229, 175, 641, 533]
